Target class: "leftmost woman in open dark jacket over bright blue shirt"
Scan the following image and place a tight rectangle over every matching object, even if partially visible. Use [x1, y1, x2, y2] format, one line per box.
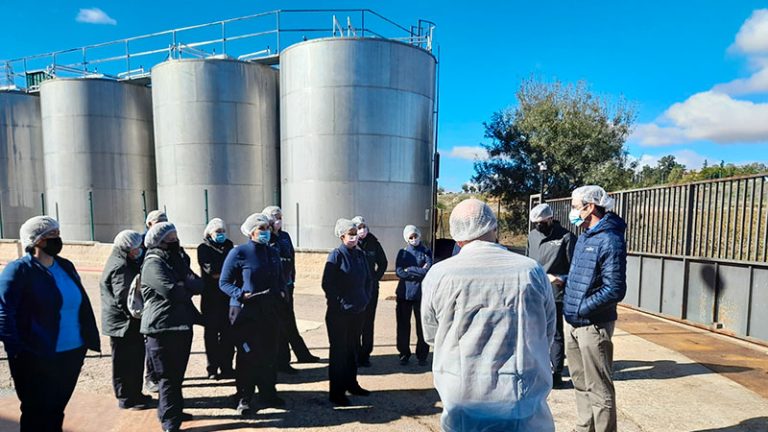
[0, 216, 100, 432]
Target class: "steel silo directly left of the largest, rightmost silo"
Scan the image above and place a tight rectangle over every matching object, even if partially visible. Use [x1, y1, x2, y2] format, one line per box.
[152, 59, 279, 243]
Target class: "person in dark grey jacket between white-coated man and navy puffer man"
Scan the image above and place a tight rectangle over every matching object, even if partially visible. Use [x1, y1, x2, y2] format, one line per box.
[528, 204, 576, 388]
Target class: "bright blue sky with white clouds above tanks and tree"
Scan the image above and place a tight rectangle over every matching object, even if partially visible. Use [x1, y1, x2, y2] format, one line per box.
[0, 0, 768, 190]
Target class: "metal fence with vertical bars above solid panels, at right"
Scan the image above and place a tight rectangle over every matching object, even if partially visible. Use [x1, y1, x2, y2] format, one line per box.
[530, 174, 768, 343]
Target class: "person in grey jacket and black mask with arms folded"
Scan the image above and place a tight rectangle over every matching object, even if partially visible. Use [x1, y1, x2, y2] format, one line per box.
[141, 222, 203, 431]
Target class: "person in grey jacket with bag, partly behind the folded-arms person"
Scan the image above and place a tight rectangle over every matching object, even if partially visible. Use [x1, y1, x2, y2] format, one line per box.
[100, 230, 152, 409]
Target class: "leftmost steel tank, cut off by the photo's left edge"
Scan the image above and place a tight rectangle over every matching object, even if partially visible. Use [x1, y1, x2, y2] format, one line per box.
[0, 91, 45, 238]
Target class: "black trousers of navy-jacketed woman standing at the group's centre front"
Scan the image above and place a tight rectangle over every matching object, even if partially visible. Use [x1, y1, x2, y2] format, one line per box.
[325, 312, 364, 397]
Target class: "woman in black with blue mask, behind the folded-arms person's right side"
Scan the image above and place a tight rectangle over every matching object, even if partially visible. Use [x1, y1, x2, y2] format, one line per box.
[197, 218, 235, 379]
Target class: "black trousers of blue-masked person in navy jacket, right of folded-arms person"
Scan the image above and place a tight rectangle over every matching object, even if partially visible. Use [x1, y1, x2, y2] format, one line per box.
[234, 295, 282, 402]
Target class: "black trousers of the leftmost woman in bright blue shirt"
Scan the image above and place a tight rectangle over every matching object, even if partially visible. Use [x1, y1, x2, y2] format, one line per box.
[8, 347, 86, 432]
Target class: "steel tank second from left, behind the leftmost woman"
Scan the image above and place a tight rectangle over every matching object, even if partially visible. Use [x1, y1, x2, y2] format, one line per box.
[40, 78, 157, 242]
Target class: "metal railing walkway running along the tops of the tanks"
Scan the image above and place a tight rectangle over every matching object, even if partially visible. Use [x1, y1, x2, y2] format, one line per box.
[0, 9, 434, 90]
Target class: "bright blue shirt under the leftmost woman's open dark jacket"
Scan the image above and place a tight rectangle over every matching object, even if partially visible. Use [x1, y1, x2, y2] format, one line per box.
[48, 261, 84, 352]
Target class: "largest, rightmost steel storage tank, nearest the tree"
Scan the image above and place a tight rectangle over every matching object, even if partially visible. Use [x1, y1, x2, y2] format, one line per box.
[280, 38, 435, 267]
